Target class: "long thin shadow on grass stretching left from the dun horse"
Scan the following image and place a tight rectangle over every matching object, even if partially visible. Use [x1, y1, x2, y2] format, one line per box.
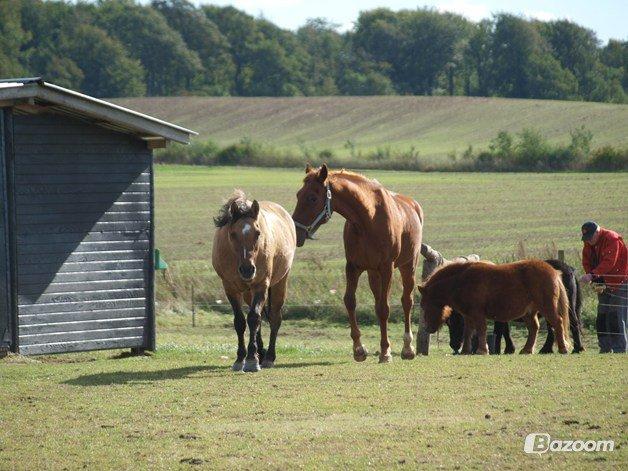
[63, 365, 231, 386]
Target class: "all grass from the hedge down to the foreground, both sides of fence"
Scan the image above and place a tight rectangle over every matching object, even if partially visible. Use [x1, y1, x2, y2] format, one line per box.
[0, 167, 628, 470]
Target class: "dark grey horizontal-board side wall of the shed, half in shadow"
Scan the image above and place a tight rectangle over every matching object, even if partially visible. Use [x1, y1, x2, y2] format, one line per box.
[14, 115, 152, 354]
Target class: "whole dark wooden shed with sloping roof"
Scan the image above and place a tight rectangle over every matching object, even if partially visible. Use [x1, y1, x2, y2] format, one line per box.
[0, 78, 195, 354]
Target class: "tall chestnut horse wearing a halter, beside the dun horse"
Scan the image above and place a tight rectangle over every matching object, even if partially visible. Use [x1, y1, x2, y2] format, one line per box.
[292, 165, 423, 363]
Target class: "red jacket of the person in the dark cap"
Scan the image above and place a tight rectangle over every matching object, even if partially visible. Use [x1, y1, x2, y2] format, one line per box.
[582, 228, 628, 290]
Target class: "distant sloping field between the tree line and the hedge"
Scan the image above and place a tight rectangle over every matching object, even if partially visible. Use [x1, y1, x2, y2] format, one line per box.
[114, 96, 628, 160]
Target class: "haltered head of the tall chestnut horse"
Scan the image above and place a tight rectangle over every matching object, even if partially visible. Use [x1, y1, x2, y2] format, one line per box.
[292, 164, 332, 247]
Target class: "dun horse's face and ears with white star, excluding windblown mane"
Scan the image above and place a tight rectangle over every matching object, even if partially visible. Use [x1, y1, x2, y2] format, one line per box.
[229, 200, 261, 281]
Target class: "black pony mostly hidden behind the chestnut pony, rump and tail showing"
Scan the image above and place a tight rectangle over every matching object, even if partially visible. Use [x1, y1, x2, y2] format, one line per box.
[495, 258, 584, 353]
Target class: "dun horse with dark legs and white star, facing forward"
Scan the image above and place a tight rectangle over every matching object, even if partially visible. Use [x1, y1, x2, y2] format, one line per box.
[212, 191, 296, 372]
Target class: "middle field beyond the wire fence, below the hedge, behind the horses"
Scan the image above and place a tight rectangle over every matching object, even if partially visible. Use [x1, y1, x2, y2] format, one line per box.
[156, 166, 628, 322]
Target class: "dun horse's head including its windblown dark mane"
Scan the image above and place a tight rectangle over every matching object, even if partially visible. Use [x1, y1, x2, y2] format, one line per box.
[215, 193, 262, 281]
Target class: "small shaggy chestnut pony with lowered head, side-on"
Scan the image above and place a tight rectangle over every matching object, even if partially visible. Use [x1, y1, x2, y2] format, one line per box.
[419, 260, 569, 354]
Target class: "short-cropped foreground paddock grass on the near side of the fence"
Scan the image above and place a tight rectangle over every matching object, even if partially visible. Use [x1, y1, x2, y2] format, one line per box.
[0, 314, 628, 470]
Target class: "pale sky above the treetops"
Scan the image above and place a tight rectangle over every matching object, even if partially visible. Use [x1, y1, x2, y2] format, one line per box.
[192, 0, 628, 43]
